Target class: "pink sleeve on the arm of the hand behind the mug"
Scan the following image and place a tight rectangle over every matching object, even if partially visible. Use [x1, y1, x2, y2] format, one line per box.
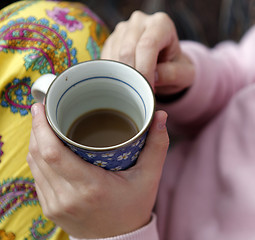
[160, 27, 255, 134]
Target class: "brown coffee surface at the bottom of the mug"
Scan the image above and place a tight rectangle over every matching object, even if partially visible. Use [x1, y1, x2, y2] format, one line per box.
[67, 109, 138, 147]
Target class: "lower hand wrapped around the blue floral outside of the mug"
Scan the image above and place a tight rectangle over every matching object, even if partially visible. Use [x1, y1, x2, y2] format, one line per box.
[27, 104, 169, 238]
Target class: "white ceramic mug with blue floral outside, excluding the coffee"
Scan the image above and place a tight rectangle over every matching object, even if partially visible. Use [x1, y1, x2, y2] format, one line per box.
[32, 60, 155, 171]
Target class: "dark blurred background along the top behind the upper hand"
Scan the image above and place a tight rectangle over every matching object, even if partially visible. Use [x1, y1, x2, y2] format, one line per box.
[0, 0, 255, 46]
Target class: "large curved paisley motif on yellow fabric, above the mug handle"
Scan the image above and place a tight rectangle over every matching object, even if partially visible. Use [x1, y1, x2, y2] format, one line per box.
[0, 17, 77, 75]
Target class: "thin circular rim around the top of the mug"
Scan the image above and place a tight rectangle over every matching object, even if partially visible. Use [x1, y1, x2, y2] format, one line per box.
[45, 59, 156, 152]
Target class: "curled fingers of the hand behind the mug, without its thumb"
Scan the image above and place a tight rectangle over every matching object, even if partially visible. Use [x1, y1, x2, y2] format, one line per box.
[102, 11, 181, 88]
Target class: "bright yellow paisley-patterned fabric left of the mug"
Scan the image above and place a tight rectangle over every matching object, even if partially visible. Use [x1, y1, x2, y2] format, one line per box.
[0, 0, 108, 240]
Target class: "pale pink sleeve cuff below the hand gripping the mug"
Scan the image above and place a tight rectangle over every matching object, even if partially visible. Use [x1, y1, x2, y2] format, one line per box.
[69, 214, 159, 240]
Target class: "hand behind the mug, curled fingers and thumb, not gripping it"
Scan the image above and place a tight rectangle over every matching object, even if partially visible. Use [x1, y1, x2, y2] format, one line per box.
[101, 11, 194, 95]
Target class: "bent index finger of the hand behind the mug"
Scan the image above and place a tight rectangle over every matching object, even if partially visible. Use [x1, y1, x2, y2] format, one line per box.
[135, 13, 180, 88]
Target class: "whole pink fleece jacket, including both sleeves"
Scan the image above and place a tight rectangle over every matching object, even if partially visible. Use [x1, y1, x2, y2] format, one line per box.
[70, 27, 255, 240]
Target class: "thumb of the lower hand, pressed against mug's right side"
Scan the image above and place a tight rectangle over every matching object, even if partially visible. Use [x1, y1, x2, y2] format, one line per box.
[136, 111, 169, 174]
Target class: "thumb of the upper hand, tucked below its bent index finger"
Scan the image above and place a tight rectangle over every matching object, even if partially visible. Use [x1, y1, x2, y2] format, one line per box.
[155, 55, 195, 95]
